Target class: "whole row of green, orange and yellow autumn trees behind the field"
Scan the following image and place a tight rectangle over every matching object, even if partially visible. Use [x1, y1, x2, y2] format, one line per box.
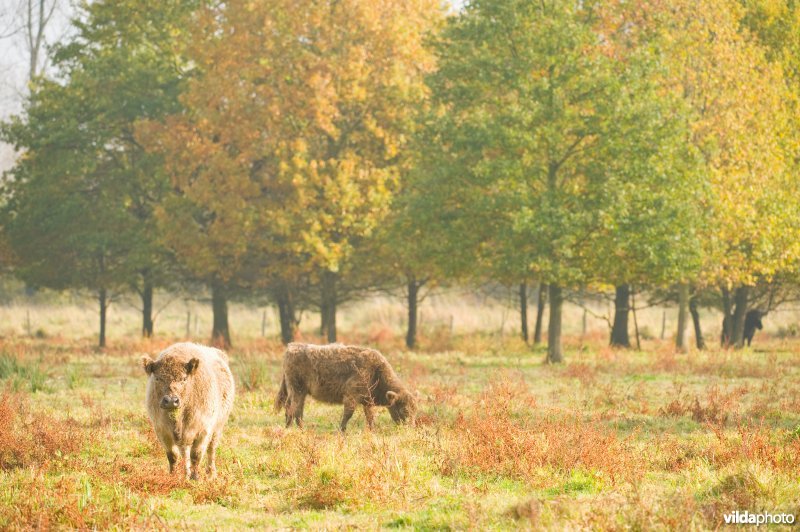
[0, 0, 800, 362]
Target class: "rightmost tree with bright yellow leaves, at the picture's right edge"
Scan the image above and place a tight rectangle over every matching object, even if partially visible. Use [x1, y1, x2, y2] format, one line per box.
[648, 1, 800, 346]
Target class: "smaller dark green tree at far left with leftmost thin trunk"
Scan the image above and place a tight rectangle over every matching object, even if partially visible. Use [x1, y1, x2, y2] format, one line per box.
[3, 78, 138, 347]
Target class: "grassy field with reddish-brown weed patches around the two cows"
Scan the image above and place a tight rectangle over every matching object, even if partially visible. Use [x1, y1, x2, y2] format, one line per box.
[0, 334, 800, 529]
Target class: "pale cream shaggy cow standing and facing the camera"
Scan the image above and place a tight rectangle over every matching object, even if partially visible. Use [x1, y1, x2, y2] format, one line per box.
[142, 343, 235, 479]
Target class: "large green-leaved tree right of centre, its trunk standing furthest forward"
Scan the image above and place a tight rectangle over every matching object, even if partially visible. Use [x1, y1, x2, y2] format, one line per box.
[424, 0, 700, 362]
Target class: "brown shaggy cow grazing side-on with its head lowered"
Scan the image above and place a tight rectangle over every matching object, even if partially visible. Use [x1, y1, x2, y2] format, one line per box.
[275, 343, 417, 432]
